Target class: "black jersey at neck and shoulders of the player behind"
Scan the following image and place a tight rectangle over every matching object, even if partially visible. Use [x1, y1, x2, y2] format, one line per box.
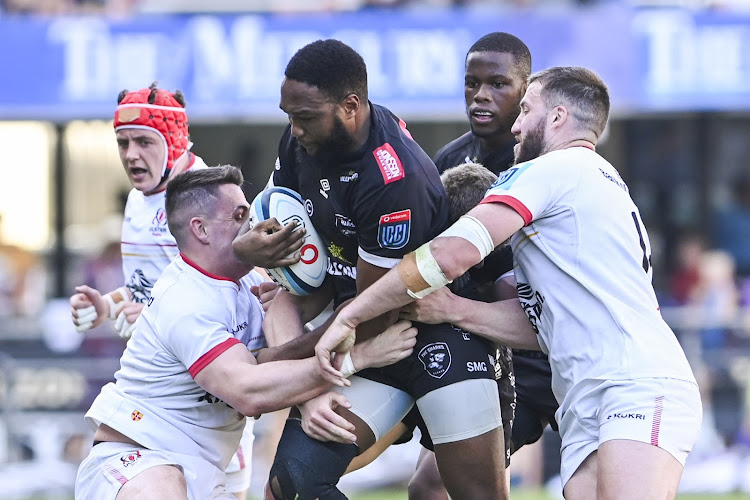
[435, 131, 516, 175]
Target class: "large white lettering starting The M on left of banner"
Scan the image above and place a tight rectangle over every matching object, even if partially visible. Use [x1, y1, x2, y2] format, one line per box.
[47, 15, 471, 103]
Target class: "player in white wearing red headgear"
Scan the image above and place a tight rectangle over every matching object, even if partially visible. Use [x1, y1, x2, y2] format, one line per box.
[70, 83, 303, 499]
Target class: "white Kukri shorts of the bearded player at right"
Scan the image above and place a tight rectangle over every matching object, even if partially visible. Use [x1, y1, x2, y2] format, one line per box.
[556, 378, 703, 487]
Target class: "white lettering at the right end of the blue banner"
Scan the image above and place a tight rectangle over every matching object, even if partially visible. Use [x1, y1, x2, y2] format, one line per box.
[633, 11, 750, 95]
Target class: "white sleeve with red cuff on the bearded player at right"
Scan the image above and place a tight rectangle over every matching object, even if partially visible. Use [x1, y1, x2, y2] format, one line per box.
[481, 159, 571, 226]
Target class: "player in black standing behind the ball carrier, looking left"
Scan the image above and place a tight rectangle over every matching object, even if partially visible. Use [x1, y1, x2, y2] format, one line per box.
[405, 32, 558, 500]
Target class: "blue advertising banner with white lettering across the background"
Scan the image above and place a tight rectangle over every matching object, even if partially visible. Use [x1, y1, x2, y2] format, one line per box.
[0, 7, 750, 122]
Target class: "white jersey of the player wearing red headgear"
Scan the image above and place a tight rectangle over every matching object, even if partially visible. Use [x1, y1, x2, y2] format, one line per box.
[121, 154, 206, 303]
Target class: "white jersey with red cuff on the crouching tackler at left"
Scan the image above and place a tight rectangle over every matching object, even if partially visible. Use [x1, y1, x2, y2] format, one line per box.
[86, 255, 266, 470]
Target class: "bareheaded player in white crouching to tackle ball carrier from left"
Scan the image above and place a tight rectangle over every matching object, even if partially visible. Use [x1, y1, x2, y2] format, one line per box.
[76, 166, 416, 500]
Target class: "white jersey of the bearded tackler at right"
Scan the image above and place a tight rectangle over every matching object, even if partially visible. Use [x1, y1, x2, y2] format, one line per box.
[482, 147, 695, 408]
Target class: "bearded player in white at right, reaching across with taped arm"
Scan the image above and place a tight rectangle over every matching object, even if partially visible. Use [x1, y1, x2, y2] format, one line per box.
[316, 67, 702, 500]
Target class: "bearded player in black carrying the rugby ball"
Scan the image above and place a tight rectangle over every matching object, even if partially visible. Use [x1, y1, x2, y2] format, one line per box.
[253, 40, 507, 500]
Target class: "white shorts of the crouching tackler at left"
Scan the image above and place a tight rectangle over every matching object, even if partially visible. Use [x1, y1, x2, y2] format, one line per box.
[75, 442, 236, 500]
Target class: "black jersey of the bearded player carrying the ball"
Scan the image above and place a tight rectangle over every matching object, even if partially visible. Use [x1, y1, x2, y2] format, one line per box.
[272, 103, 449, 305]
